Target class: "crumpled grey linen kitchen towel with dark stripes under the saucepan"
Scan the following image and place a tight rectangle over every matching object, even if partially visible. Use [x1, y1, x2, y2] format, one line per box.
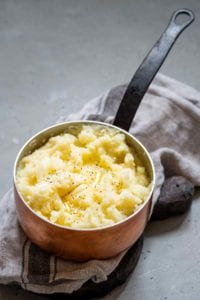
[0, 74, 200, 294]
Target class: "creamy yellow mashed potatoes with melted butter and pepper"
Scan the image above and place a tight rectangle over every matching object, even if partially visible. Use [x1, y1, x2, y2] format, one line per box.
[16, 125, 150, 228]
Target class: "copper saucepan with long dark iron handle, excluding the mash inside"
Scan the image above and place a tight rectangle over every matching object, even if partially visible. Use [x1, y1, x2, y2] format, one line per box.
[14, 9, 194, 261]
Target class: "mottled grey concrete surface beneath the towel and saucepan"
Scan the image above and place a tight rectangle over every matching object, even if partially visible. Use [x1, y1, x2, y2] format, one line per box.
[0, 0, 200, 300]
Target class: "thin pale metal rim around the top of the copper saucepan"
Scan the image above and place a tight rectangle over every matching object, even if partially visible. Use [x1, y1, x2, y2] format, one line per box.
[13, 120, 155, 232]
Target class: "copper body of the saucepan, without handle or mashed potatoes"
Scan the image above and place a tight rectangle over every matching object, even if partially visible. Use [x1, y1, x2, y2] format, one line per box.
[14, 121, 155, 260]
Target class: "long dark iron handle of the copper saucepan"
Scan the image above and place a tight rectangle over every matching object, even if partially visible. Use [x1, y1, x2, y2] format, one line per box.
[113, 9, 195, 131]
